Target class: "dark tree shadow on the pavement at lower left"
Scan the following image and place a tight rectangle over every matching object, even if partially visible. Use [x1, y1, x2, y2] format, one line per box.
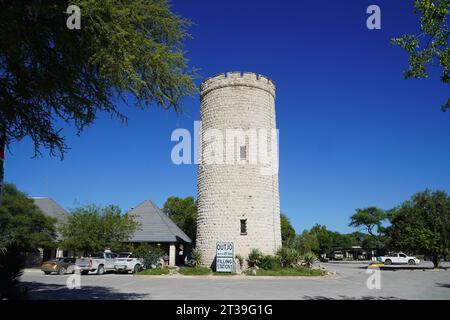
[20, 281, 148, 300]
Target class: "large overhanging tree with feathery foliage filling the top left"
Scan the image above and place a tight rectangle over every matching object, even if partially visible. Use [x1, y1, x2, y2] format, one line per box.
[0, 0, 196, 202]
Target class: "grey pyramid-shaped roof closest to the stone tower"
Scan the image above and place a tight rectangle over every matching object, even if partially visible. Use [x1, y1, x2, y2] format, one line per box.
[129, 200, 192, 243]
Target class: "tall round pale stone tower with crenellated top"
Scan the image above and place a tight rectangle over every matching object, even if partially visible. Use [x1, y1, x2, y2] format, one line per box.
[196, 72, 281, 266]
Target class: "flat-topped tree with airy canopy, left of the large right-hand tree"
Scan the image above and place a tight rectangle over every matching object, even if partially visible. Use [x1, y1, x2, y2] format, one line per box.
[349, 207, 387, 244]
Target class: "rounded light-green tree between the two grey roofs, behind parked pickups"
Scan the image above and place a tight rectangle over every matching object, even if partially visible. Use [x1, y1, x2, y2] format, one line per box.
[60, 205, 140, 252]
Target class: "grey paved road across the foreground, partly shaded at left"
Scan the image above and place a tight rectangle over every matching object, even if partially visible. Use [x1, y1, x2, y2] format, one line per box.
[21, 264, 450, 300]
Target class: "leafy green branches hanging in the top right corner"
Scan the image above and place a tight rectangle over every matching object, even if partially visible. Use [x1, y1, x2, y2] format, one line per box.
[391, 0, 450, 111]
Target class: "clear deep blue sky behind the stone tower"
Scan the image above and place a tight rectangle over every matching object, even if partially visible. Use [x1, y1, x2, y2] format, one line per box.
[5, 0, 450, 232]
